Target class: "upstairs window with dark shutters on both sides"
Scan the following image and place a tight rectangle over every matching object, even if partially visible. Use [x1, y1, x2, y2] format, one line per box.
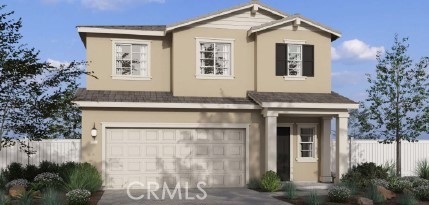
[276, 40, 314, 80]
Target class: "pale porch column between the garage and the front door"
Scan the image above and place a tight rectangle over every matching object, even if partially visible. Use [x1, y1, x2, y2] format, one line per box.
[263, 111, 279, 172]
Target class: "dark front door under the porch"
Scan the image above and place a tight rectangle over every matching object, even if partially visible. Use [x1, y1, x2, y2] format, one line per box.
[277, 127, 290, 181]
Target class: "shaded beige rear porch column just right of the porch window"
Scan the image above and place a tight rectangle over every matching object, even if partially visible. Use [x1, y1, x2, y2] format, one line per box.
[319, 117, 332, 183]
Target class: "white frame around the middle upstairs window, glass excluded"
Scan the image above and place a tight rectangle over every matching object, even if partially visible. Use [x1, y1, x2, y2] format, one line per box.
[195, 37, 235, 80]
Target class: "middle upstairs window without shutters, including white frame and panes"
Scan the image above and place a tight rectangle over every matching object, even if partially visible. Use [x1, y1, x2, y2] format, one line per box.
[196, 39, 233, 79]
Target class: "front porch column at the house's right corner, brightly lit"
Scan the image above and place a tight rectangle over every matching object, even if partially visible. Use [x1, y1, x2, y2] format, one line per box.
[335, 113, 349, 183]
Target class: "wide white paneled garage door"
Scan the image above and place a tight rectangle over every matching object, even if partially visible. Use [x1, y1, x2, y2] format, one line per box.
[106, 129, 246, 189]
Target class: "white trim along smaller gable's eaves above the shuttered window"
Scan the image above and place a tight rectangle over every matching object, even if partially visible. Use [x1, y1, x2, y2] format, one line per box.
[247, 14, 341, 40]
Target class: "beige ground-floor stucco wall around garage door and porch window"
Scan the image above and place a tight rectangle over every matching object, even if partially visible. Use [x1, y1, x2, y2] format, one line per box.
[82, 109, 321, 181]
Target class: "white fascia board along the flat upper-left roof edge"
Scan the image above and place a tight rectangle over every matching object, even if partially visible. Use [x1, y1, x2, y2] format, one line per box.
[77, 26, 165, 36]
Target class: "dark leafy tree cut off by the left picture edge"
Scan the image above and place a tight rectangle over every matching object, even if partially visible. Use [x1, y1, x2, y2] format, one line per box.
[0, 5, 92, 154]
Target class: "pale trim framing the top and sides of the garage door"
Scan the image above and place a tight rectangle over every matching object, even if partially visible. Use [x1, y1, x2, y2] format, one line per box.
[101, 122, 250, 186]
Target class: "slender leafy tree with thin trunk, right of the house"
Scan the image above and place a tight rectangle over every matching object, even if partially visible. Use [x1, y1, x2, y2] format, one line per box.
[361, 35, 429, 176]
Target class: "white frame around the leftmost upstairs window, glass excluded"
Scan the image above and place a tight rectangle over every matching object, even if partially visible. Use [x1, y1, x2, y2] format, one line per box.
[111, 39, 152, 80]
